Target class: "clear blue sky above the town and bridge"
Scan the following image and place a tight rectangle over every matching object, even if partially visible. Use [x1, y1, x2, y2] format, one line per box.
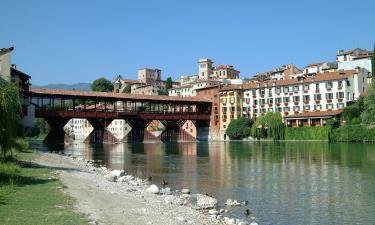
[0, 0, 375, 85]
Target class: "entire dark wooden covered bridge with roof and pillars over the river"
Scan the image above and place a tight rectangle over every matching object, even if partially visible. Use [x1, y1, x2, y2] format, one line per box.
[28, 88, 211, 143]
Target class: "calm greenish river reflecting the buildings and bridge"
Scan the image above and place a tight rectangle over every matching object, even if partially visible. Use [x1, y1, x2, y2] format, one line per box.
[31, 142, 375, 224]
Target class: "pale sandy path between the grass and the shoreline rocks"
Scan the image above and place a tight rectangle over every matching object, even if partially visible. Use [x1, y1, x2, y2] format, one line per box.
[35, 153, 220, 225]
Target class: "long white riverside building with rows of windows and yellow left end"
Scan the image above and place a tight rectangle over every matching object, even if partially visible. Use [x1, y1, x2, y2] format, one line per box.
[219, 68, 370, 139]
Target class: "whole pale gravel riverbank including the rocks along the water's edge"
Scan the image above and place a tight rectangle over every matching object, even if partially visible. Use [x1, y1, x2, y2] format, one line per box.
[35, 153, 256, 225]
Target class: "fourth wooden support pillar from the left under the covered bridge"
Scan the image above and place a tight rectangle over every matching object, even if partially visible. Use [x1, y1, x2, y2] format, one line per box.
[160, 120, 196, 142]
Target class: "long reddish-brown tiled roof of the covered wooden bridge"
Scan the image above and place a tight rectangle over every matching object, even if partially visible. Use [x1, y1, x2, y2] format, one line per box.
[30, 88, 211, 103]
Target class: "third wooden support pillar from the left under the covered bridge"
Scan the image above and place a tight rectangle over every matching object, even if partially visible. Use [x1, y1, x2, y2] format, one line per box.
[124, 119, 160, 142]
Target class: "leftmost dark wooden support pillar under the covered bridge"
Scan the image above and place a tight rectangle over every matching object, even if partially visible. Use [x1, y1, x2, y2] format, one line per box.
[43, 117, 70, 144]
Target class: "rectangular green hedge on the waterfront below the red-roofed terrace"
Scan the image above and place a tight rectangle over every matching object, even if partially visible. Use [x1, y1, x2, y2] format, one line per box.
[285, 126, 330, 140]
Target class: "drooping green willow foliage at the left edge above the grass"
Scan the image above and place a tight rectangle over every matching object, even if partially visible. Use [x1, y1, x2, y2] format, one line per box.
[0, 83, 21, 156]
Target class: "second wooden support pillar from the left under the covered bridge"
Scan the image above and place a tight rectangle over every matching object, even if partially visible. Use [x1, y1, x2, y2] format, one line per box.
[84, 118, 118, 143]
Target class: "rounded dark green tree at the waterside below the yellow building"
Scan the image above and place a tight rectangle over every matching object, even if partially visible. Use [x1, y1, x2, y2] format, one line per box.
[225, 117, 253, 140]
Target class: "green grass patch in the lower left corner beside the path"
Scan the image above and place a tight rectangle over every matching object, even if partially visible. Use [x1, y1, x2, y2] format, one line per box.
[0, 151, 89, 225]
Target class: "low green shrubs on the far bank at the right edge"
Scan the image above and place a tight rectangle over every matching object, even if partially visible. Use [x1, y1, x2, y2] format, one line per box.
[330, 124, 375, 142]
